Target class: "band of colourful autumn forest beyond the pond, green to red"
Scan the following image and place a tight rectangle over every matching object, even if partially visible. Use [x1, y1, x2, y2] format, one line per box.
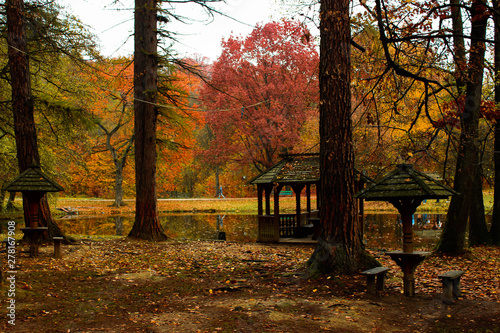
[0, 1, 496, 211]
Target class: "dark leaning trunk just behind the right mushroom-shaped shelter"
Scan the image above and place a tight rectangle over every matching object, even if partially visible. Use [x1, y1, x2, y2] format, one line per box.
[437, 0, 488, 253]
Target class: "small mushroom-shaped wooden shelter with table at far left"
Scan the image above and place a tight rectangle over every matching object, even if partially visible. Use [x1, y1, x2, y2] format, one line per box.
[4, 165, 63, 257]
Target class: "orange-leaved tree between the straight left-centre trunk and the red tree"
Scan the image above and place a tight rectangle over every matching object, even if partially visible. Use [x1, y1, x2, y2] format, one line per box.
[157, 59, 204, 196]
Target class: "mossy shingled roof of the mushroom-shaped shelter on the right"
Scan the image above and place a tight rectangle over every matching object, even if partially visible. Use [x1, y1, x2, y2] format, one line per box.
[355, 164, 458, 201]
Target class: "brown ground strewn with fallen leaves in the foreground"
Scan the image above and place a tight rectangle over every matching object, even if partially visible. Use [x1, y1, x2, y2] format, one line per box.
[0, 238, 500, 332]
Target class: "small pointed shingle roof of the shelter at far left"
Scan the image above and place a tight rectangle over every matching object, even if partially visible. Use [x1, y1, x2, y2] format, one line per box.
[3, 166, 64, 192]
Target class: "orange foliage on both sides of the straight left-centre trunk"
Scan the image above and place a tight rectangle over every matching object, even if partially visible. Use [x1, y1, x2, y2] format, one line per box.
[62, 58, 201, 198]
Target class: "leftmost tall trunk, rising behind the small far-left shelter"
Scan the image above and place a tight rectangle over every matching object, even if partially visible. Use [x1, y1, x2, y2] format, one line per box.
[5, 0, 62, 238]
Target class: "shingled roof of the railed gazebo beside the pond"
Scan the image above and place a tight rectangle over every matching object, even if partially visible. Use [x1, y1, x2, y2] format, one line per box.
[250, 154, 319, 185]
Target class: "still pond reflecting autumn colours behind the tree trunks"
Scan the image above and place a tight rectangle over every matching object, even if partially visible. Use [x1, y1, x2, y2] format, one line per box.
[0, 213, 454, 249]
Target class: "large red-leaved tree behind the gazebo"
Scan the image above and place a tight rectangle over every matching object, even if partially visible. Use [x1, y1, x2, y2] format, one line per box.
[200, 20, 318, 171]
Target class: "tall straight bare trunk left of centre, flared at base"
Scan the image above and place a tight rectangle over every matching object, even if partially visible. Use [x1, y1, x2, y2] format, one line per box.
[128, 0, 167, 241]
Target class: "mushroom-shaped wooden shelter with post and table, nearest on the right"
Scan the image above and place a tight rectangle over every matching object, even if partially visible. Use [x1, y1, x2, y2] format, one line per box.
[356, 164, 457, 296]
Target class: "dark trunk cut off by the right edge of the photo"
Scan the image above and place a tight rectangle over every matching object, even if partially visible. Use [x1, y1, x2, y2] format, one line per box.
[490, 0, 500, 245]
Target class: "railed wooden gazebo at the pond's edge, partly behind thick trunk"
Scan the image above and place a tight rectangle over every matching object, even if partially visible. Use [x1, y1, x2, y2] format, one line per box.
[250, 153, 368, 242]
